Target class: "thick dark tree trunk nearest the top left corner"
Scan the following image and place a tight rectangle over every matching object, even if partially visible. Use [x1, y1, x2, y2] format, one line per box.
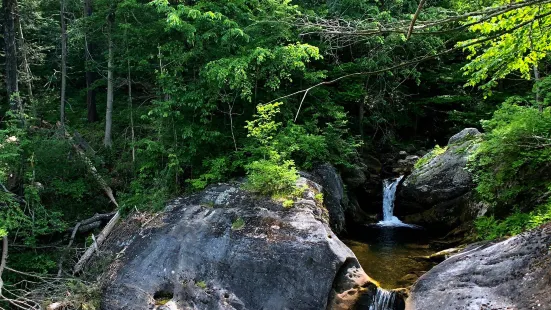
[2, 0, 22, 113]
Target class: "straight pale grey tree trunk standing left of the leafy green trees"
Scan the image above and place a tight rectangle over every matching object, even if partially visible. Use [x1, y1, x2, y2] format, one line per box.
[103, 8, 115, 147]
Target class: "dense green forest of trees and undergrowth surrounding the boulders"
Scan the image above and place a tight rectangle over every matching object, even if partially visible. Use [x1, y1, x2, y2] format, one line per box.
[0, 0, 551, 309]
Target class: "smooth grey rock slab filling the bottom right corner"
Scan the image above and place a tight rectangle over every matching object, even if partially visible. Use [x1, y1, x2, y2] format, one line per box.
[406, 224, 551, 310]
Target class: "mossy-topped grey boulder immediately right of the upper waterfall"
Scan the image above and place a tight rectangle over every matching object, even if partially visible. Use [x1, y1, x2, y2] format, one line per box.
[395, 128, 483, 231]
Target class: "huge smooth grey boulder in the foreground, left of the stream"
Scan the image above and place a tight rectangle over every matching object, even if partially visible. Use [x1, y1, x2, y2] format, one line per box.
[102, 178, 374, 310]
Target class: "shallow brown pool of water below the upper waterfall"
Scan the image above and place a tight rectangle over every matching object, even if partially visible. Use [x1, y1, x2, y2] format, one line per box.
[344, 225, 440, 289]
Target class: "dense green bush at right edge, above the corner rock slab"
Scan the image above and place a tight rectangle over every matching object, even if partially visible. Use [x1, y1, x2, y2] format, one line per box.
[469, 103, 551, 239]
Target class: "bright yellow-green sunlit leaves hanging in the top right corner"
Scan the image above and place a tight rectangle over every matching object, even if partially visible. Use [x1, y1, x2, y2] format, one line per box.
[458, 1, 551, 94]
